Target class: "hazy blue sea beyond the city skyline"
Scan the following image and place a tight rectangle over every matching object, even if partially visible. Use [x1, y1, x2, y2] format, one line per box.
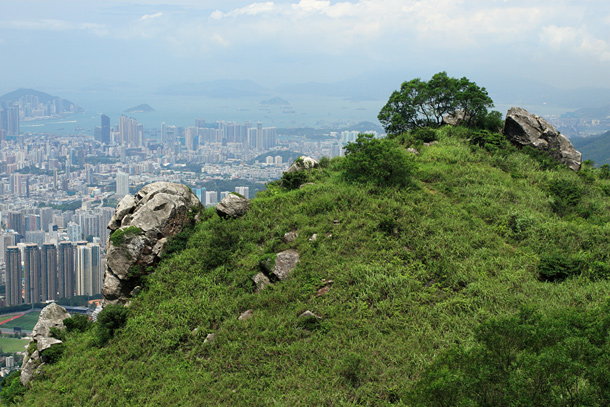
[20, 91, 386, 136]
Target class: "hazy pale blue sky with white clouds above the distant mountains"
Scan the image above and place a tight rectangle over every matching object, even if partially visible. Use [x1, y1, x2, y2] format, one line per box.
[0, 0, 610, 91]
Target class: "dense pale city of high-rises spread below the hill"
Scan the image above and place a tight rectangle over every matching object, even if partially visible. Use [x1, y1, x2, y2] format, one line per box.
[0, 91, 376, 374]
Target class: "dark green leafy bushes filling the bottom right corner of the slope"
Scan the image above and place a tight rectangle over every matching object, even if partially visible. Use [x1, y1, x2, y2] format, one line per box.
[411, 305, 610, 407]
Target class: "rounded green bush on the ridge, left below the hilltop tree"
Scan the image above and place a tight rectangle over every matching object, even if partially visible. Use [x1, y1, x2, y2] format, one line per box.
[342, 134, 415, 187]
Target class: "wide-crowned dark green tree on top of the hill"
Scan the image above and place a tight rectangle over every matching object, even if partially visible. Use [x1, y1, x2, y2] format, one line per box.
[377, 72, 493, 134]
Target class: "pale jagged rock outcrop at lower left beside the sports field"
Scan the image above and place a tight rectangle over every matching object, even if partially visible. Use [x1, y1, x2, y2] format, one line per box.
[20, 303, 70, 386]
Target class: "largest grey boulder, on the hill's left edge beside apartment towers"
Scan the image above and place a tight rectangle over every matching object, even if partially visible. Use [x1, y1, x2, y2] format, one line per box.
[102, 182, 203, 305]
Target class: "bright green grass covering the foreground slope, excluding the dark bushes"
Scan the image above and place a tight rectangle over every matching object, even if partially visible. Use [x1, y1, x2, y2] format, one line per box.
[16, 129, 610, 406]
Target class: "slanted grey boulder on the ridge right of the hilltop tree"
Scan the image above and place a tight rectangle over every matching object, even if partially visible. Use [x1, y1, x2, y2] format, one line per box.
[504, 107, 582, 171]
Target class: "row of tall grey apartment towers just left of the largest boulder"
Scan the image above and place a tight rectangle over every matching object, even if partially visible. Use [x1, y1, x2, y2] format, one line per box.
[5, 241, 104, 305]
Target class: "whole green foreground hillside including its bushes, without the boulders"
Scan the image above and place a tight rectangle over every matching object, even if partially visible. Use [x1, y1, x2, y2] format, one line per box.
[9, 127, 610, 407]
